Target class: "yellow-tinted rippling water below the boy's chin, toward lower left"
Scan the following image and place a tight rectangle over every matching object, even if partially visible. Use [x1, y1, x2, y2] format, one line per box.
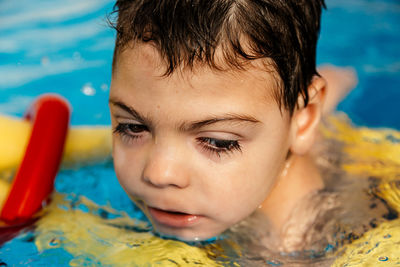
[35, 194, 238, 266]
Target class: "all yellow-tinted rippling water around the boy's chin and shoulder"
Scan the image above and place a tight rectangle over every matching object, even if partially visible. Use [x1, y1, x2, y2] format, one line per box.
[0, 115, 400, 267]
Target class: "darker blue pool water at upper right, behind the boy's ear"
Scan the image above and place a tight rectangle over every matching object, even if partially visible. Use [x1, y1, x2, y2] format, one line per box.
[318, 0, 400, 129]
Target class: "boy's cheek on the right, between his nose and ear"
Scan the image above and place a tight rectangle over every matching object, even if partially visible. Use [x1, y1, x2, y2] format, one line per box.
[208, 136, 287, 223]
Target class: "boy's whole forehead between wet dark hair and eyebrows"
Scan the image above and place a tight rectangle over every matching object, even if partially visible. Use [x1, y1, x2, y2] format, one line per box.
[110, 44, 288, 122]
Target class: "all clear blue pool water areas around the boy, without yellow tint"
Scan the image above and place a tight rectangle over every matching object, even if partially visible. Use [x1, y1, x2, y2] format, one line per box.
[0, 0, 400, 265]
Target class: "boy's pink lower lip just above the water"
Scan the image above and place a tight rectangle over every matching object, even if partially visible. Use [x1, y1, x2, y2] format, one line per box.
[149, 207, 201, 228]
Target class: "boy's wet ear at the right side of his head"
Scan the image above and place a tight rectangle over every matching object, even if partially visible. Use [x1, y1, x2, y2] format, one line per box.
[290, 76, 326, 155]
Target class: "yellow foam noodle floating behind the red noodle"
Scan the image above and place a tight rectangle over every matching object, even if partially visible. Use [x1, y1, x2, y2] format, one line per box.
[0, 115, 111, 173]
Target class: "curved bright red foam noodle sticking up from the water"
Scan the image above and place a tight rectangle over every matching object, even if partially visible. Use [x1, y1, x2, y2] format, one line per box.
[0, 94, 70, 223]
